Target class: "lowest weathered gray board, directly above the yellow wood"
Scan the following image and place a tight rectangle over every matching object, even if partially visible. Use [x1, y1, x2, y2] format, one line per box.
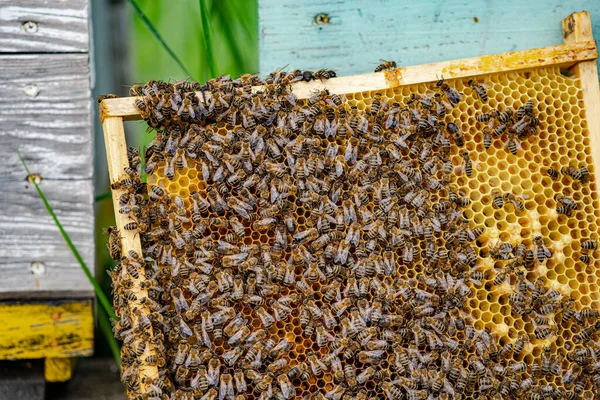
[0, 179, 94, 299]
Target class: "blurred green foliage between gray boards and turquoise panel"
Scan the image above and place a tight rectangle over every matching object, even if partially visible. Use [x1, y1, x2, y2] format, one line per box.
[129, 0, 258, 82]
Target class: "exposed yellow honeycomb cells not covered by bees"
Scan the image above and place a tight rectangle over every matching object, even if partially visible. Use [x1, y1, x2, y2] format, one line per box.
[148, 67, 600, 399]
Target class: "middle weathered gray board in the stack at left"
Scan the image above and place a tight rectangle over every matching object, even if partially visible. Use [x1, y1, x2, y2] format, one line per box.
[0, 54, 93, 179]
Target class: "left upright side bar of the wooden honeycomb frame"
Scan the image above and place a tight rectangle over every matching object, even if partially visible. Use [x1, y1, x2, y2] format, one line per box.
[102, 117, 158, 393]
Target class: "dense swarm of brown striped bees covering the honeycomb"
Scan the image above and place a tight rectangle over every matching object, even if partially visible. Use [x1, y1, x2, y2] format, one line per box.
[107, 62, 600, 400]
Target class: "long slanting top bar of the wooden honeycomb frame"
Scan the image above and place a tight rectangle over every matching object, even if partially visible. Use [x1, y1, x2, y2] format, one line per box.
[100, 41, 598, 120]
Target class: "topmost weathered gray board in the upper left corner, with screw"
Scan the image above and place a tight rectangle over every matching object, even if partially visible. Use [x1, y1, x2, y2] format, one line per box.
[0, 0, 89, 53]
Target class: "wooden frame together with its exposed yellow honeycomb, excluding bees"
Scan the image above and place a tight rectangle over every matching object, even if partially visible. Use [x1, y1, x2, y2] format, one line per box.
[104, 10, 600, 398]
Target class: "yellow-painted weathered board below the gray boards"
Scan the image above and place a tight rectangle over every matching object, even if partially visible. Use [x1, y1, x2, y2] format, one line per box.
[0, 300, 94, 360]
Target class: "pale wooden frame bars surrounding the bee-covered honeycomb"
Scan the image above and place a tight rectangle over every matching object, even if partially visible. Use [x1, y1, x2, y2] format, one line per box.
[100, 11, 600, 396]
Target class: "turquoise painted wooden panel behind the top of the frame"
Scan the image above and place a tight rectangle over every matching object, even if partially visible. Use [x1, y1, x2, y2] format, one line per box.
[259, 0, 600, 75]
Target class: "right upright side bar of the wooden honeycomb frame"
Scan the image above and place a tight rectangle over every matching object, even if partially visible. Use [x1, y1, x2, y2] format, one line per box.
[562, 12, 600, 203]
